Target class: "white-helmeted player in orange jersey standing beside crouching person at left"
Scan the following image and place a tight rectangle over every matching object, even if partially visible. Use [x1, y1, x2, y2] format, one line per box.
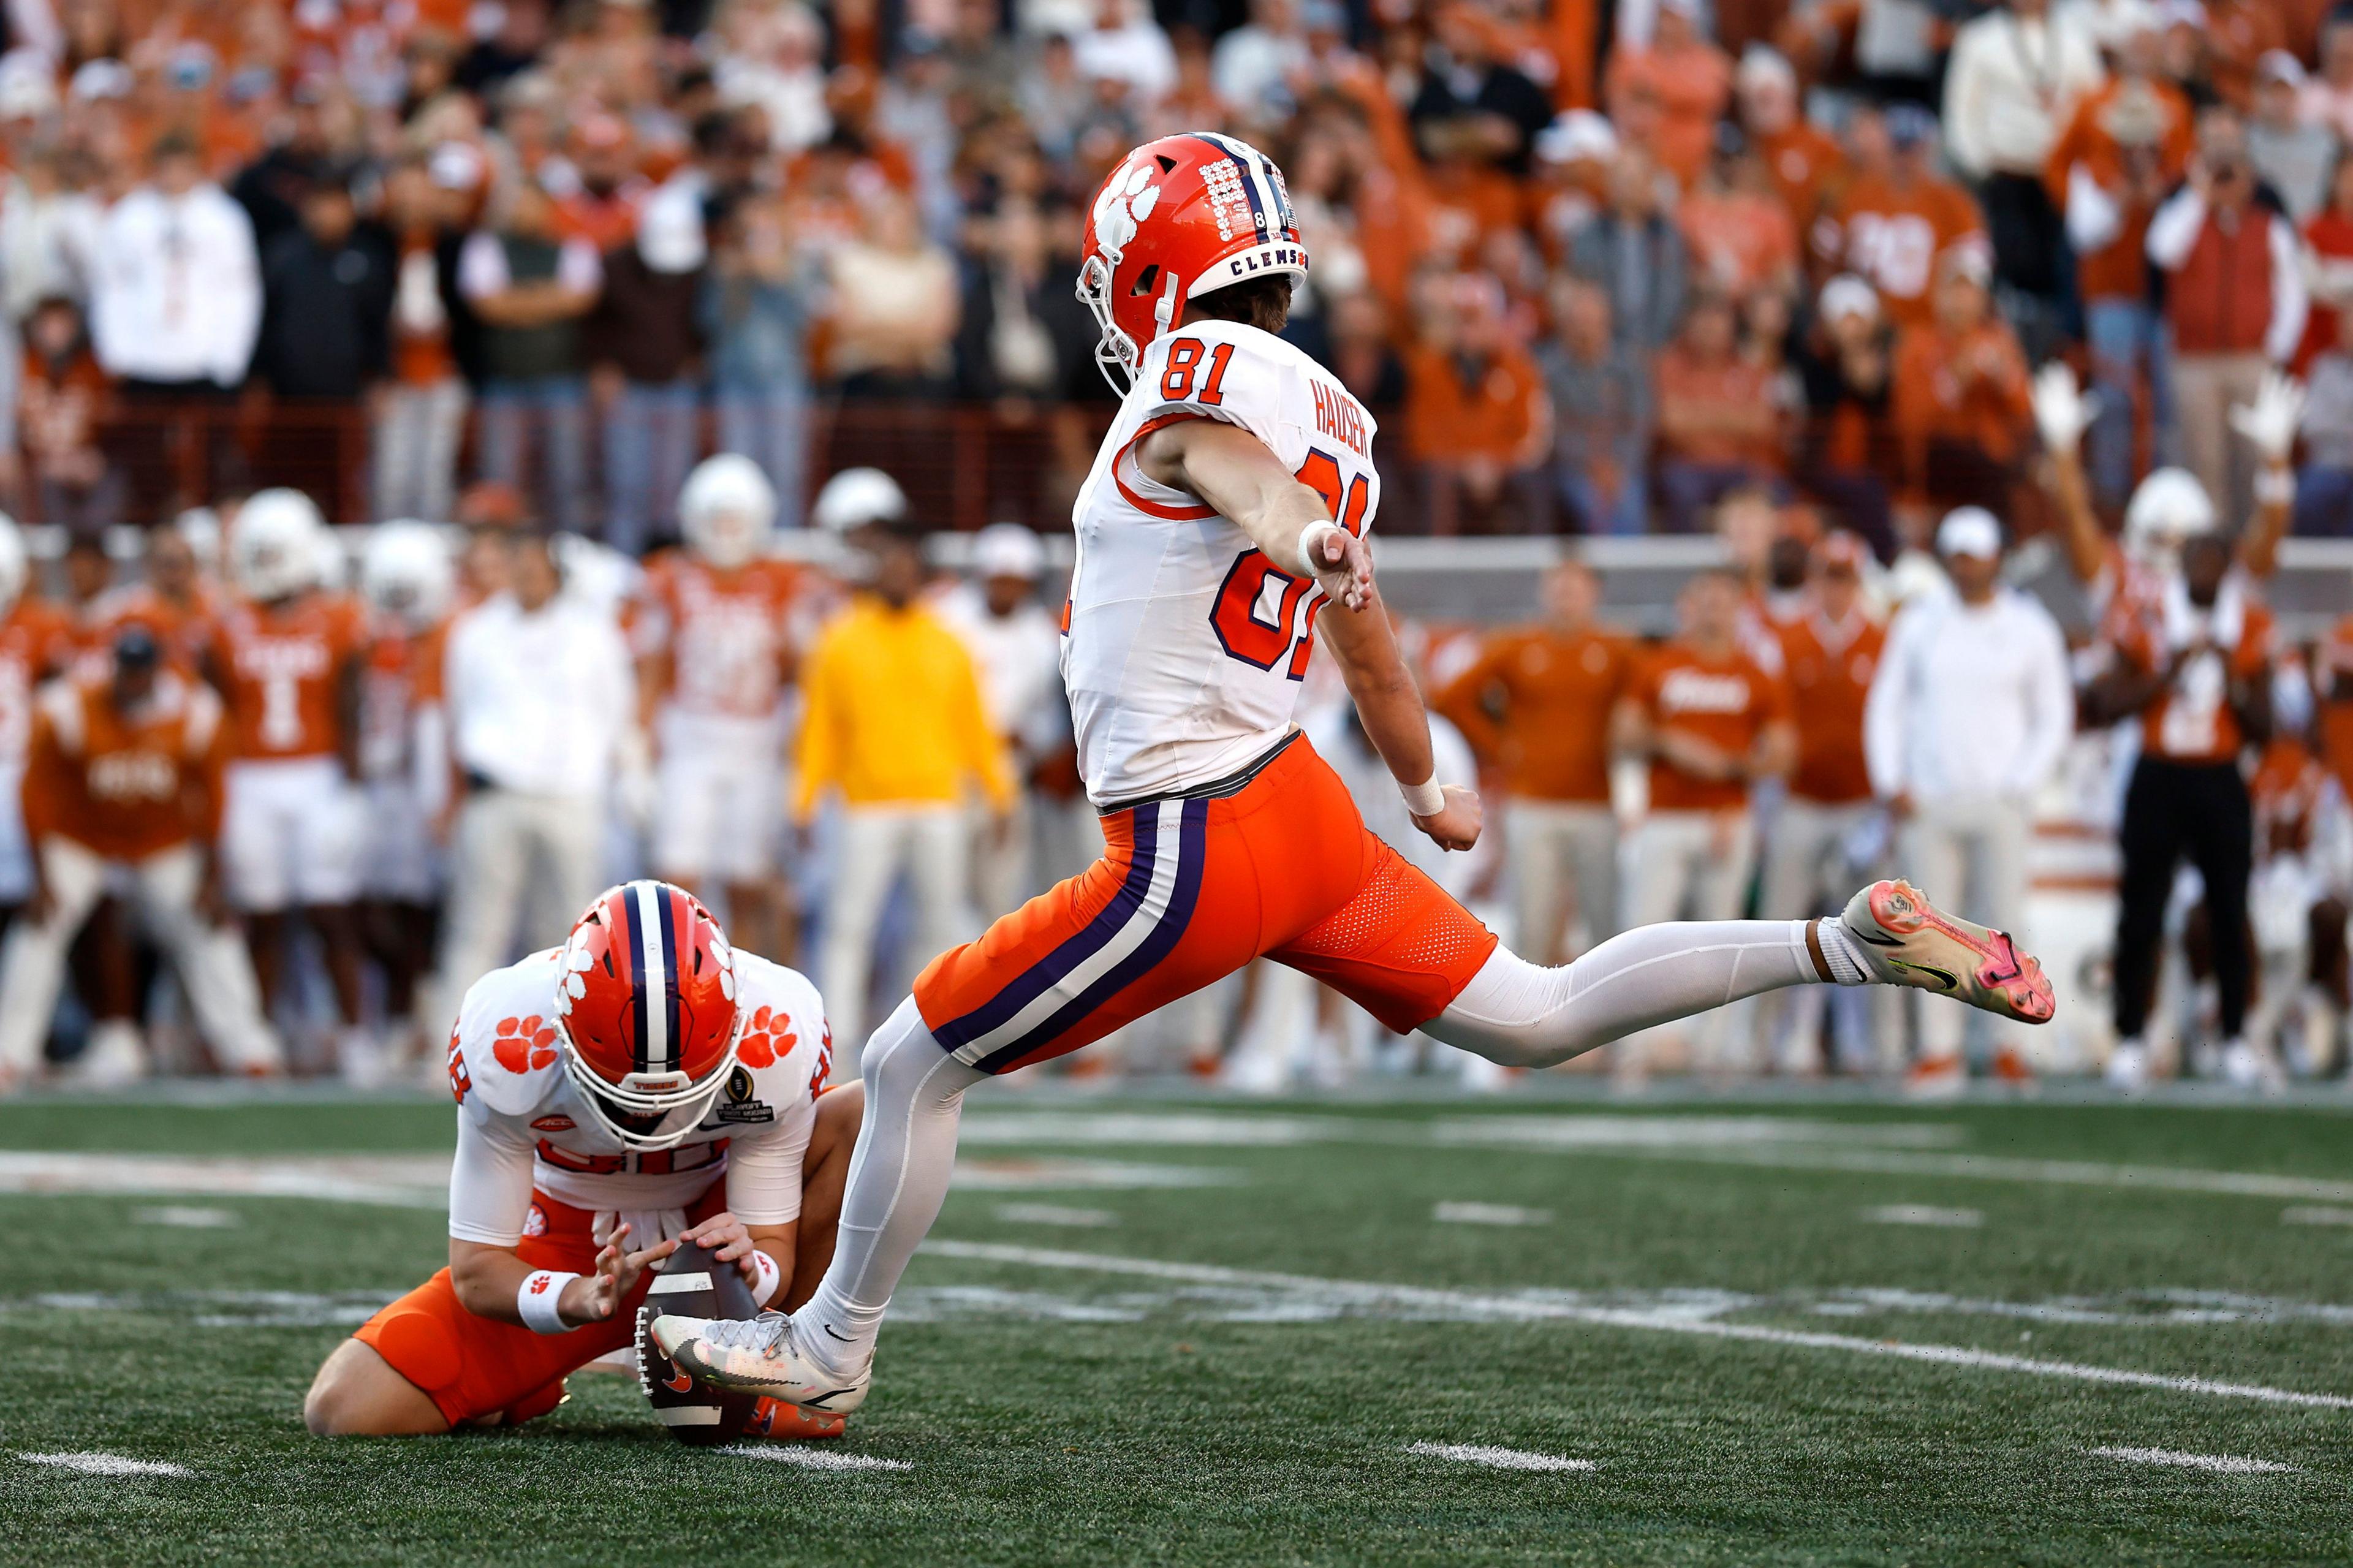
[207, 490, 381, 1078]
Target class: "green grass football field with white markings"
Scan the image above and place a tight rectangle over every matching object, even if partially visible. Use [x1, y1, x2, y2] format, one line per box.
[0, 1093, 2353, 1568]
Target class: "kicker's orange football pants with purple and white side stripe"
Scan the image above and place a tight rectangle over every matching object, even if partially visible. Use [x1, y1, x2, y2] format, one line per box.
[915, 735, 1496, 1074]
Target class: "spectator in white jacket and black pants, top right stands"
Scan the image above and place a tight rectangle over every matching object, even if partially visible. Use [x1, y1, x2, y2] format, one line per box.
[1944, 0, 2106, 325]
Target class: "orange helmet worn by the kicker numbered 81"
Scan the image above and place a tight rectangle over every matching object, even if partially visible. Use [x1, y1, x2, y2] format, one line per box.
[1078, 132, 1308, 393]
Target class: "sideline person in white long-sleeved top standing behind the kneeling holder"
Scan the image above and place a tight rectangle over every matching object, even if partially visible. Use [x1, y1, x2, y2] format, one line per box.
[440, 537, 638, 1017]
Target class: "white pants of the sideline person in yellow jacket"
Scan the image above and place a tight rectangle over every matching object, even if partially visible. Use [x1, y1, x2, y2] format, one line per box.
[816, 803, 972, 1081]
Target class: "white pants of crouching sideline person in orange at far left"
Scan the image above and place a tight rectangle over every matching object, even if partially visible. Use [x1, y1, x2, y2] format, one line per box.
[0, 838, 282, 1074]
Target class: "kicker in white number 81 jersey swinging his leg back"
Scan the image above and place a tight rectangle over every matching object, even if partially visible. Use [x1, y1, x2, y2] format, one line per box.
[654, 134, 2052, 1412]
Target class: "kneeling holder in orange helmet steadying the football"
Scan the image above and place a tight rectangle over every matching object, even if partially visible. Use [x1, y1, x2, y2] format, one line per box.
[303, 881, 863, 1436]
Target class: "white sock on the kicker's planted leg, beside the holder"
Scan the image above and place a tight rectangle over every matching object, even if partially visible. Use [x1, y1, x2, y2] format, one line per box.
[793, 996, 988, 1373]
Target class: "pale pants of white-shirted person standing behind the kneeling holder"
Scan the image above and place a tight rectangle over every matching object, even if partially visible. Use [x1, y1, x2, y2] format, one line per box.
[433, 789, 605, 1026]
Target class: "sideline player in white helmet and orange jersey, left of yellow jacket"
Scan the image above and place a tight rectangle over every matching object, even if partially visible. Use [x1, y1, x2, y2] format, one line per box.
[631, 452, 800, 953]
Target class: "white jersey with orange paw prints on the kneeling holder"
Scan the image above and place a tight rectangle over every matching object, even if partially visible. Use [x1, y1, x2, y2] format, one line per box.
[449, 947, 833, 1246]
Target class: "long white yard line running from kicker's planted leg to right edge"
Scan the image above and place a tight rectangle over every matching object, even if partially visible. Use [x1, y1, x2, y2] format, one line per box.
[925, 1241, 2353, 1411]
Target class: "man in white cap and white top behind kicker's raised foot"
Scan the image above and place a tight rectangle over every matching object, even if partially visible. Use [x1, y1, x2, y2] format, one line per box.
[1863, 506, 2075, 1090]
